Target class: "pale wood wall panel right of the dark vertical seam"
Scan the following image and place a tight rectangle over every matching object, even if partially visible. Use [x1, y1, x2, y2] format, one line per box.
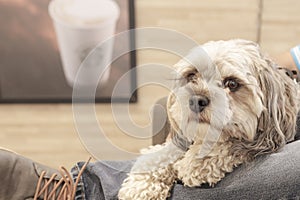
[261, 0, 300, 55]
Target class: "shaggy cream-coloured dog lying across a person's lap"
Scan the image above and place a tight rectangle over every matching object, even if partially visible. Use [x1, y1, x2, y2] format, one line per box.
[118, 39, 299, 200]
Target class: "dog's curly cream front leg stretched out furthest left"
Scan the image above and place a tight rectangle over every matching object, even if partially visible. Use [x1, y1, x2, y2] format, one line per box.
[118, 142, 184, 200]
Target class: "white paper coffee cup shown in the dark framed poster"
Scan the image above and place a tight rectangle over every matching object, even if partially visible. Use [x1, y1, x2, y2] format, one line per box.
[49, 0, 120, 86]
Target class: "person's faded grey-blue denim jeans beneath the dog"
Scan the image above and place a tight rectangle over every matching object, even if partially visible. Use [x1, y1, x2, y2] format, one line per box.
[78, 141, 300, 200]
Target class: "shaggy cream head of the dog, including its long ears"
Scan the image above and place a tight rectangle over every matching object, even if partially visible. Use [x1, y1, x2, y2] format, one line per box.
[168, 40, 299, 156]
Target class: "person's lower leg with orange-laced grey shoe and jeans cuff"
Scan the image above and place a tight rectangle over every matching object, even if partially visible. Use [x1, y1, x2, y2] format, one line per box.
[0, 146, 129, 200]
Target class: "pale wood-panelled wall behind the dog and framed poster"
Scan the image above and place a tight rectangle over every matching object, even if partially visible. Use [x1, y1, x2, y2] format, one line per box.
[0, 0, 300, 167]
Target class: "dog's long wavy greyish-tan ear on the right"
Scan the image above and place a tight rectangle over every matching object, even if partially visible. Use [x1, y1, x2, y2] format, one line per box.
[252, 58, 299, 155]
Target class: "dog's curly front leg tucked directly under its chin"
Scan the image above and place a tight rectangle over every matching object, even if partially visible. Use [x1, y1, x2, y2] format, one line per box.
[174, 143, 242, 187]
